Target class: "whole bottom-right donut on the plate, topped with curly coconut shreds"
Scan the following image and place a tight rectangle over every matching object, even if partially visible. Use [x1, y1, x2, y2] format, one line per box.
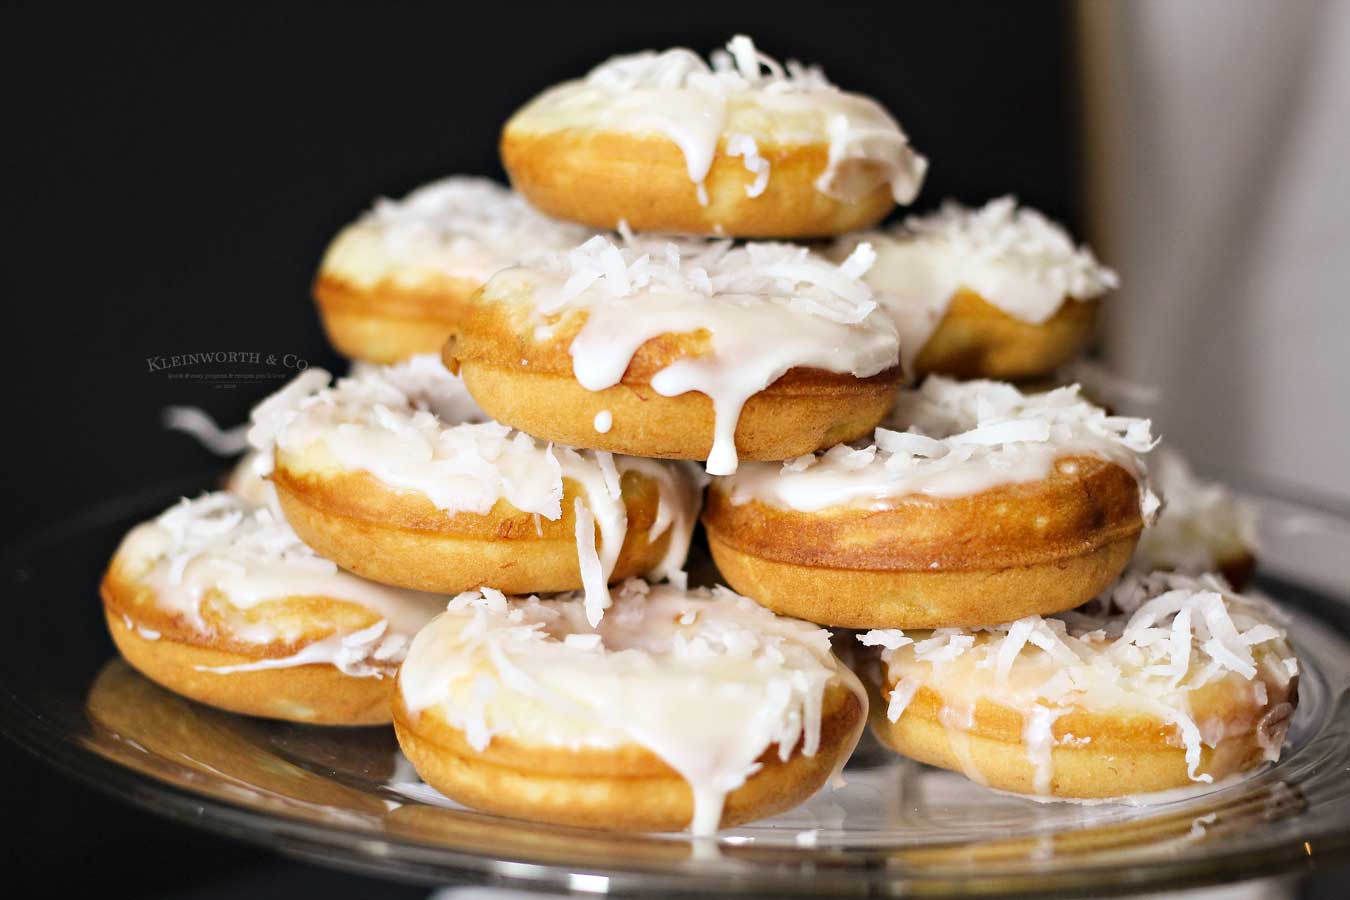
[859, 572, 1299, 799]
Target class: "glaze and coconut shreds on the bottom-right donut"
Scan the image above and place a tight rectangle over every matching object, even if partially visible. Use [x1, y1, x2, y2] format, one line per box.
[859, 572, 1299, 793]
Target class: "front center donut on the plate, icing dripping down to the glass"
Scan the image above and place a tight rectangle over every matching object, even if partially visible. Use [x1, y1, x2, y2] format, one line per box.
[394, 579, 867, 834]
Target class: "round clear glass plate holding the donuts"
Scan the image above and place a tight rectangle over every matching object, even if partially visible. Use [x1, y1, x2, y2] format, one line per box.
[0, 478, 1350, 896]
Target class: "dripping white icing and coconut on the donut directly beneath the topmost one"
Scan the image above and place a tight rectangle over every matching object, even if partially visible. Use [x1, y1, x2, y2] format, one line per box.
[483, 236, 898, 475]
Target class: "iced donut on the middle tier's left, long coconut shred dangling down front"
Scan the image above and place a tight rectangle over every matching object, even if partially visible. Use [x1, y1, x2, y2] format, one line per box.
[248, 360, 702, 617]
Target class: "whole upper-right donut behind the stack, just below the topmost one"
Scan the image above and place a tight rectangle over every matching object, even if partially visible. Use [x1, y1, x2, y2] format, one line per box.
[832, 197, 1118, 381]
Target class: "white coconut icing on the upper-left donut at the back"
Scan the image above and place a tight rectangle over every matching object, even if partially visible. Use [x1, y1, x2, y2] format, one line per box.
[321, 175, 591, 287]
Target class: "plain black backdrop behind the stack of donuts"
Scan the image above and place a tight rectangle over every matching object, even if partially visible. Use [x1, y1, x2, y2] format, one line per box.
[0, 1, 1079, 896]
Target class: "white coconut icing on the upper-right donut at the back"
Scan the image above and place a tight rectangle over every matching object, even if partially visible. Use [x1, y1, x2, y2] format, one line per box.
[836, 197, 1119, 371]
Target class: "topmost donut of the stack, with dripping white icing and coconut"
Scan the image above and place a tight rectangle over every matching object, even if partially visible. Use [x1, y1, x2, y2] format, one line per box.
[501, 35, 927, 239]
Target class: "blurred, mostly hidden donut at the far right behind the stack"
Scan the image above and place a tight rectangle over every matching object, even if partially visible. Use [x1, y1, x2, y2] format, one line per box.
[1131, 447, 1257, 591]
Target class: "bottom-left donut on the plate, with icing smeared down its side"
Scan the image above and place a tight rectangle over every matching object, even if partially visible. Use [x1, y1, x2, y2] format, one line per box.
[101, 493, 447, 725]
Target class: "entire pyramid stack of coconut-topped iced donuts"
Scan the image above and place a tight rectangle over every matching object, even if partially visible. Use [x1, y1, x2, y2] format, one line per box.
[103, 36, 1297, 834]
